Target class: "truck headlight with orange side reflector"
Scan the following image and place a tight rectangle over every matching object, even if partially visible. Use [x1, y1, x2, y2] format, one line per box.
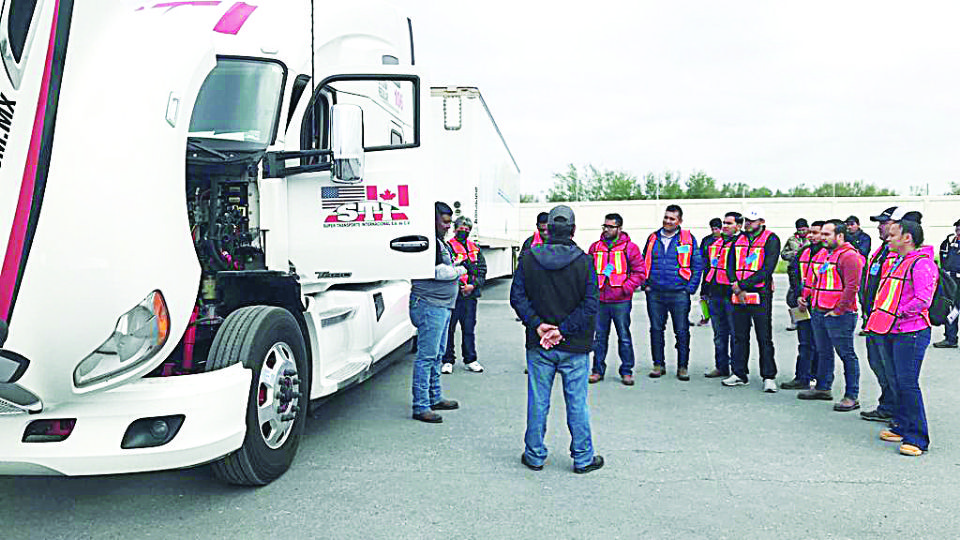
[73, 291, 170, 388]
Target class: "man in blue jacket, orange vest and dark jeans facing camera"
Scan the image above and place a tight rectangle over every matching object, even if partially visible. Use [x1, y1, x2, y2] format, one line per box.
[643, 204, 703, 381]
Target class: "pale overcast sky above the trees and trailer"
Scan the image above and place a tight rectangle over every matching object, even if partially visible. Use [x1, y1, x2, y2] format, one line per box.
[397, 0, 960, 198]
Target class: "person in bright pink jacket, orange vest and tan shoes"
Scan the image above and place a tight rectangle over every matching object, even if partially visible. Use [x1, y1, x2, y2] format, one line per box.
[866, 219, 939, 456]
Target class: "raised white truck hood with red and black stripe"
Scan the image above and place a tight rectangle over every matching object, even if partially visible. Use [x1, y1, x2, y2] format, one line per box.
[0, 0, 216, 404]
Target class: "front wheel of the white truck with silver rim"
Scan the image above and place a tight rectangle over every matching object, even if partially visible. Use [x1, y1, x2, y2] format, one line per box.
[206, 306, 310, 486]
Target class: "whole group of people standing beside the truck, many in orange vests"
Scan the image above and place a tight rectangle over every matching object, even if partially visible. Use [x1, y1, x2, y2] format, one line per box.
[410, 202, 960, 473]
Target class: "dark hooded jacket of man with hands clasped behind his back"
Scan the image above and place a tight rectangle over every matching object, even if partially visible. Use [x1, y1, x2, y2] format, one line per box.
[510, 240, 599, 353]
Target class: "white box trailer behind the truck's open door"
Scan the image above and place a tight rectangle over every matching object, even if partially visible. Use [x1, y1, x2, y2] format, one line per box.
[427, 86, 520, 278]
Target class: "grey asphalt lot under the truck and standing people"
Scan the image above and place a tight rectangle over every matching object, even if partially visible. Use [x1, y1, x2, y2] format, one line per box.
[0, 276, 960, 539]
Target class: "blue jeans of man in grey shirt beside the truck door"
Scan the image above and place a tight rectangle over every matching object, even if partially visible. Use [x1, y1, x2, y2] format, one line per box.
[410, 295, 450, 414]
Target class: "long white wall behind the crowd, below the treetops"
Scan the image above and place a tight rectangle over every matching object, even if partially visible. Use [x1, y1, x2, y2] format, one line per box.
[520, 196, 960, 249]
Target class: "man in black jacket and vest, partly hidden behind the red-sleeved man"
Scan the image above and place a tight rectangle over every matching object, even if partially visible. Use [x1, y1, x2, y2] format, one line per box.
[780, 221, 824, 390]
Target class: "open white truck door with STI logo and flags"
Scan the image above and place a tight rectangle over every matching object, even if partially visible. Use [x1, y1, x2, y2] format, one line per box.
[278, 70, 436, 283]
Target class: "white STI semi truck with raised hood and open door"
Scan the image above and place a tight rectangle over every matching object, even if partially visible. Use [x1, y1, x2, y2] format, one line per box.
[0, 0, 518, 485]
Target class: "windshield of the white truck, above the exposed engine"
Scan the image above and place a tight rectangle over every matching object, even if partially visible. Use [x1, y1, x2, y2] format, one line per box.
[190, 58, 284, 145]
